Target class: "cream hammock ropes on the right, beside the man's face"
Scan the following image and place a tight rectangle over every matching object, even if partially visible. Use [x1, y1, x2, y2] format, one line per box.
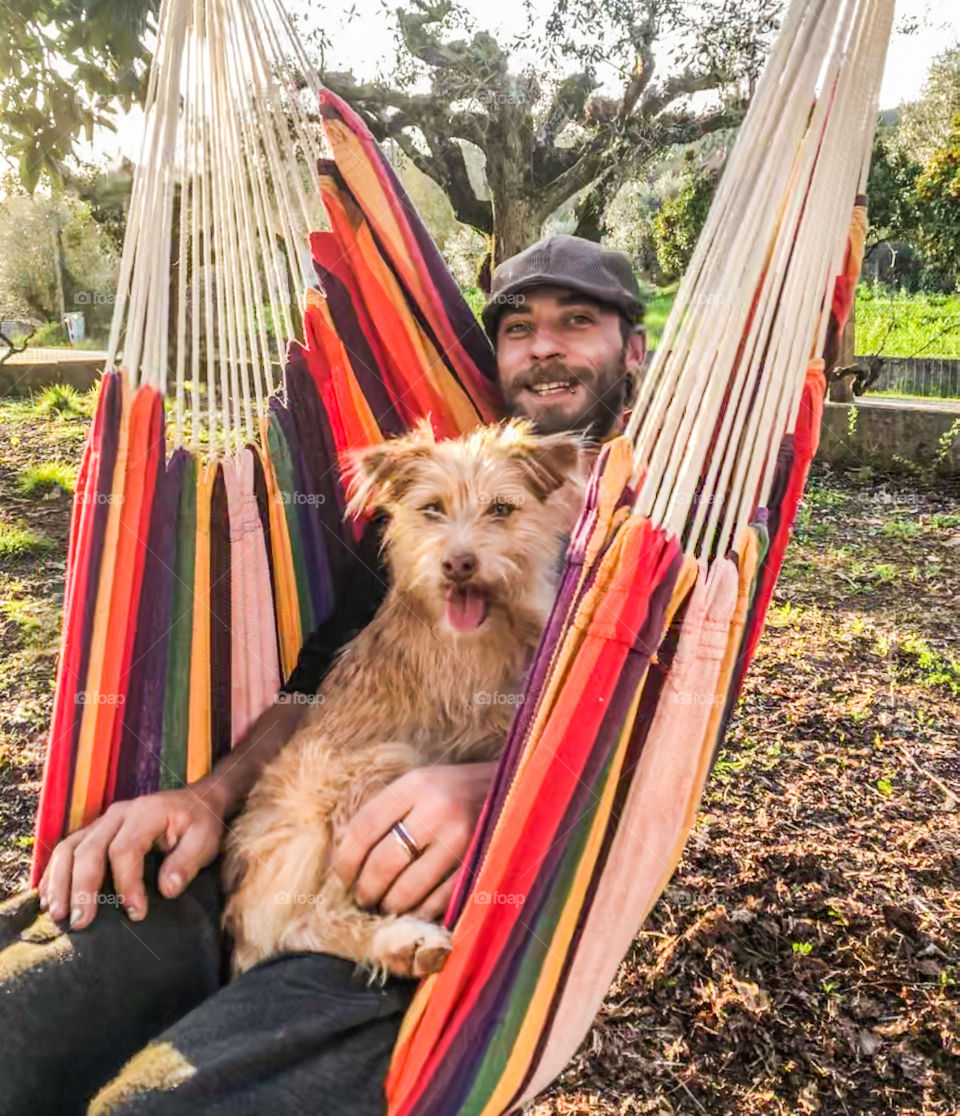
[627, 0, 893, 558]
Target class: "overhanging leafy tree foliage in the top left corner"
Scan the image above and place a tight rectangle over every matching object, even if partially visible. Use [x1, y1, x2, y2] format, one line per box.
[0, 0, 159, 193]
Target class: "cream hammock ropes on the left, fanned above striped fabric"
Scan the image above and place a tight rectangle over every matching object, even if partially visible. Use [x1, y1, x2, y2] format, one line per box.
[108, 0, 325, 456]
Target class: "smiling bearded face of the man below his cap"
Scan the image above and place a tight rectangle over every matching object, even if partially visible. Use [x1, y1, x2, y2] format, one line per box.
[497, 287, 644, 439]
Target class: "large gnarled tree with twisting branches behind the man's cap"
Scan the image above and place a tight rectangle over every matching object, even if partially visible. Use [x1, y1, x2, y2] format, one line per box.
[323, 0, 780, 261]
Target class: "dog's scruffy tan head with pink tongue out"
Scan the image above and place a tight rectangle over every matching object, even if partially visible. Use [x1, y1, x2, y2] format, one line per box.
[348, 420, 587, 638]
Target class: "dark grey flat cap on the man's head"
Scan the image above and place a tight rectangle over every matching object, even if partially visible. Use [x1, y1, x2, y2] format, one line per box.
[481, 233, 643, 341]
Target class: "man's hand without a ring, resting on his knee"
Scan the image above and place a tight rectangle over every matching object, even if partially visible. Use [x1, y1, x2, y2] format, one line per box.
[39, 780, 227, 930]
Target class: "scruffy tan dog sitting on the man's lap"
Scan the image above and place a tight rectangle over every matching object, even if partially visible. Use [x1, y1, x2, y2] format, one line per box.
[224, 420, 587, 977]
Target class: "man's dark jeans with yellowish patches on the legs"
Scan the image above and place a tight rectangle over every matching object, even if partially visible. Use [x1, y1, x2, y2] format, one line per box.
[0, 857, 415, 1116]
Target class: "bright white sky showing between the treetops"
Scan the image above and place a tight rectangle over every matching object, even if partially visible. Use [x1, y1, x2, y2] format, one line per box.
[94, 0, 960, 160]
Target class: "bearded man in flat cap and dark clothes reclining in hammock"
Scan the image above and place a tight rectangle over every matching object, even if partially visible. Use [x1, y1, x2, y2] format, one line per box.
[0, 235, 644, 1116]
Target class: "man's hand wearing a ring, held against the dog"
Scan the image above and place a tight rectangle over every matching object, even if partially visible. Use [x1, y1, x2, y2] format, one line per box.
[333, 763, 497, 922]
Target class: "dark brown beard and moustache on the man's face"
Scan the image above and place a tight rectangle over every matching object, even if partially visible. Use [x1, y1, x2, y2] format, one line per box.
[502, 347, 633, 442]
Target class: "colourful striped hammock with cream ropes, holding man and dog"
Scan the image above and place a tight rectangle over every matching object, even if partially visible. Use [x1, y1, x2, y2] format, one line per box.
[32, 0, 892, 1116]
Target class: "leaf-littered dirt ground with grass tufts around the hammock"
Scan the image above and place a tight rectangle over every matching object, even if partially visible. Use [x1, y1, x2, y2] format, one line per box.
[0, 390, 960, 1116]
